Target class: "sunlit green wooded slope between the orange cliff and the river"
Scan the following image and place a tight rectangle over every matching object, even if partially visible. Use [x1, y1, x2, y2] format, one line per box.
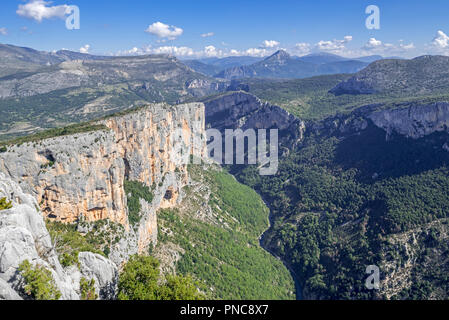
[156, 166, 295, 299]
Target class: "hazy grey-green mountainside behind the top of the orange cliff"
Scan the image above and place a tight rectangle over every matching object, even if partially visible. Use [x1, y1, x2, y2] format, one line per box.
[0, 45, 226, 137]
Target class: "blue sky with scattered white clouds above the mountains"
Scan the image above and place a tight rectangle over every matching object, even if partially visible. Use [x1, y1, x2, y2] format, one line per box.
[0, 0, 449, 58]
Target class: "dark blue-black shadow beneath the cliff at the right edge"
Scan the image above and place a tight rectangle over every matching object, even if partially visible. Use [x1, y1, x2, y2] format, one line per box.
[334, 125, 449, 183]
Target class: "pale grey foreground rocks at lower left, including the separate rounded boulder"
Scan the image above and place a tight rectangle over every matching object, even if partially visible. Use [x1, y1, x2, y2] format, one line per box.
[0, 173, 118, 300]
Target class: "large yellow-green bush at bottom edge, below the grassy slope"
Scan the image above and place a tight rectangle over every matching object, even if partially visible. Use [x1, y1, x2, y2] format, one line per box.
[118, 256, 204, 300]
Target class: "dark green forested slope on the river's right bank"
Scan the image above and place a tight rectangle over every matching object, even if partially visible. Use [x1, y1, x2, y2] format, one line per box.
[230, 122, 449, 299]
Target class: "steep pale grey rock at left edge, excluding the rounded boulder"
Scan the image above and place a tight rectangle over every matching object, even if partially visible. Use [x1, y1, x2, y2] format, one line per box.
[0, 173, 79, 300]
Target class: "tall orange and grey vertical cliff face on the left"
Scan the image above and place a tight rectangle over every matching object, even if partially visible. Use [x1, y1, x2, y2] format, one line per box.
[0, 103, 206, 258]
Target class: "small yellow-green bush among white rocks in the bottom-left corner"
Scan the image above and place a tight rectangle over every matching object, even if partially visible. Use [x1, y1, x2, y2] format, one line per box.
[19, 260, 61, 300]
